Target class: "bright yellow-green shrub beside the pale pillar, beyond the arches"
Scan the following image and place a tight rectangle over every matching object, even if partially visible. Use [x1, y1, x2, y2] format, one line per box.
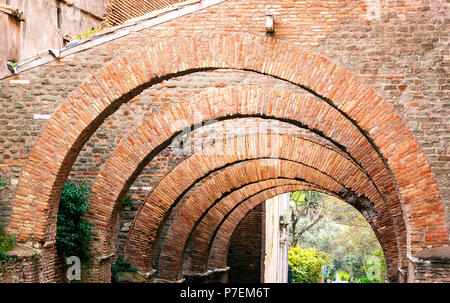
[289, 246, 331, 283]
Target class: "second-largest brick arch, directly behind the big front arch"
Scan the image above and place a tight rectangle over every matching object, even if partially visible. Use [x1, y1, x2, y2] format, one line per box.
[98, 87, 406, 262]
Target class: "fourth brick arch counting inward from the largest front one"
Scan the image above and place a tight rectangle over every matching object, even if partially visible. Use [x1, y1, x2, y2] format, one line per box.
[154, 157, 390, 280]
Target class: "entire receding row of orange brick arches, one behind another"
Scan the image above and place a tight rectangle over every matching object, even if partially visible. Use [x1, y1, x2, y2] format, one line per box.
[9, 34, 448, 281]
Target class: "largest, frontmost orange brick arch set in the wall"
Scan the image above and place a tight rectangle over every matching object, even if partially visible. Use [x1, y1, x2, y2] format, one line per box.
[9, 33, 448, 280]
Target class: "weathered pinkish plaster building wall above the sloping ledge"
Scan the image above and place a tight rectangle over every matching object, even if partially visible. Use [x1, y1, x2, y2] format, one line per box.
[0, 0, 105, 64]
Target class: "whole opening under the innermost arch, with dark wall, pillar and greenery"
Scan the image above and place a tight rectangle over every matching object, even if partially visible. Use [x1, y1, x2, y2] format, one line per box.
[227, 189, 386, 283]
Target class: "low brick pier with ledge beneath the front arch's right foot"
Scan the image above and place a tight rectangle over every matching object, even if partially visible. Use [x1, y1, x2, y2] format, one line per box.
[408, 246, 450, 283]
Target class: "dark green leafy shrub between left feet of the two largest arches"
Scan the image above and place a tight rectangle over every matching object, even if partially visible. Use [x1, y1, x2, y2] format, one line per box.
[56, 180, 93, 261]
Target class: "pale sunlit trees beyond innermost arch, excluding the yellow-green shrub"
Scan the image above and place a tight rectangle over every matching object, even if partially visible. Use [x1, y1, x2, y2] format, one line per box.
[290, 191, 386, 283]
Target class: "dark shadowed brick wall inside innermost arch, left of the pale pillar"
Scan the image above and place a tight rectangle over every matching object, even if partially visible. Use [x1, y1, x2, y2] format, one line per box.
[227, 204, 265, 283]
